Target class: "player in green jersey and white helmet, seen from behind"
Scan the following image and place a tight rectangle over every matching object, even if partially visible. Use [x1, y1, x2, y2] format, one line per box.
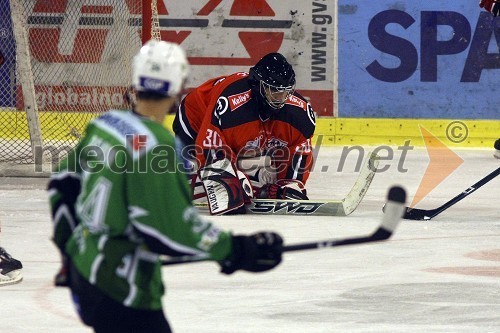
[48, 41, 283, 333]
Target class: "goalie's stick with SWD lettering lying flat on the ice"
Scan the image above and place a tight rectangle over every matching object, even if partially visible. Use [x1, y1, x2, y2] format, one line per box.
[195, 153, 379, 216]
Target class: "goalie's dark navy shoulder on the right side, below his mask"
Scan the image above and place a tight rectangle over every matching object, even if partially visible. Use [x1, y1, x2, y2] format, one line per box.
[277, 92, 316, 138]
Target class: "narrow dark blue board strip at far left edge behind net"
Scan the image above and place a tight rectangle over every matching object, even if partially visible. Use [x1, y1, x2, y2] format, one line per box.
[0, 0, 16, 107]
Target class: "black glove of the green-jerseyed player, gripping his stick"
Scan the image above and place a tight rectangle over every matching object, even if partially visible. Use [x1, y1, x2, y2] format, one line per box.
[219, 232, 283, 274]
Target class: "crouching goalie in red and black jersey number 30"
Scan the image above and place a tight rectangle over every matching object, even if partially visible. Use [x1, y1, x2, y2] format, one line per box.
[173, 53, 316, 214]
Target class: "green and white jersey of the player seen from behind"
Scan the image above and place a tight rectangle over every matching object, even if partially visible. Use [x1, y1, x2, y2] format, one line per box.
[49, 110, 231, 309]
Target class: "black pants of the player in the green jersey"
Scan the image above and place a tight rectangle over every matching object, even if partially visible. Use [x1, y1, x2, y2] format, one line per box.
[70, 264, 172, 333]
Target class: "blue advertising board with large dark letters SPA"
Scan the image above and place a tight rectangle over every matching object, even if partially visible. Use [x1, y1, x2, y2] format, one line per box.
[338, 0, 500, 119]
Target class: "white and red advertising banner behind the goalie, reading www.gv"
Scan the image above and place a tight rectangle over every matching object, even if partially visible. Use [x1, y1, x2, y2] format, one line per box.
[158, 0, 336, 115]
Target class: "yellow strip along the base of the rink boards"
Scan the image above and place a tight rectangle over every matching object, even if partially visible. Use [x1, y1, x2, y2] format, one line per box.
[0, 110, 500, 148]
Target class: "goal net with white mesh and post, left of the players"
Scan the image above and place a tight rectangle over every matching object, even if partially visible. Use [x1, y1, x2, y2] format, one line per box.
[0, 0, 159, 176]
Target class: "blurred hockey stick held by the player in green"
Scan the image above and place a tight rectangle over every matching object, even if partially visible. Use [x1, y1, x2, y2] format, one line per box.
[162, 186, 406, 266]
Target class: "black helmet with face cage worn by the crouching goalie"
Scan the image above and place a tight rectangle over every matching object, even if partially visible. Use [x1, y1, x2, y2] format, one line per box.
[249, 53, 295, 111]
